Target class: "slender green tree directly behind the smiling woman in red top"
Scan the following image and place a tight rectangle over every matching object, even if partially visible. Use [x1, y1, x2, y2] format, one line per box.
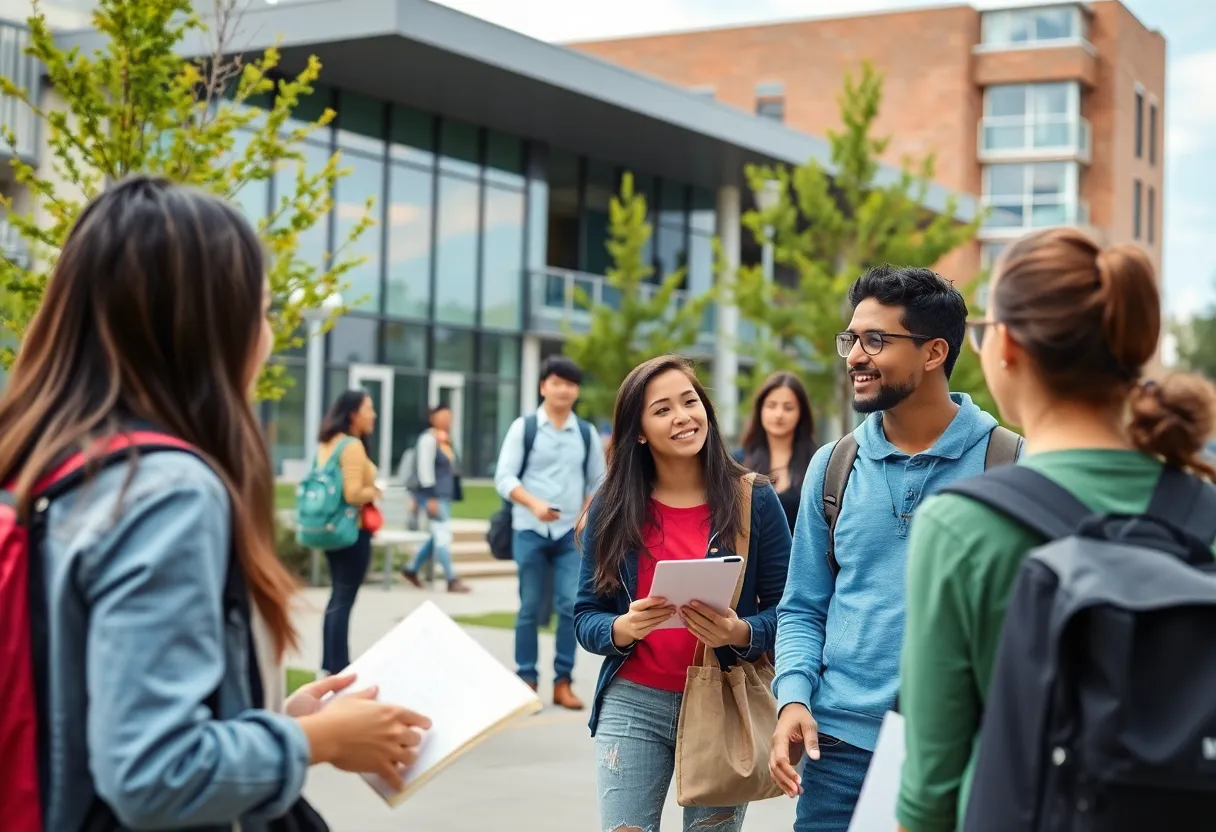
[565, 173, 715, 420]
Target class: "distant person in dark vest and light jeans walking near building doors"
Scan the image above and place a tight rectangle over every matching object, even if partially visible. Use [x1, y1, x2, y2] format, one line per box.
[401, 405, 469, 592]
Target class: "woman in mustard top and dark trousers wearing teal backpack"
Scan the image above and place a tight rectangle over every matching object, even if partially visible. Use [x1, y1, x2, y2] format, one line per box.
[316, 390, 381, 674]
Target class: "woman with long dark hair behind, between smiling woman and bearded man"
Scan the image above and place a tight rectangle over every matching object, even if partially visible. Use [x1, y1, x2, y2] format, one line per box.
[741, 372, 815, 533]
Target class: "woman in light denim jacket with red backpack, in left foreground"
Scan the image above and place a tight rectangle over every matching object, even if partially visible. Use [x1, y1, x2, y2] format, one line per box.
[0, 178, 426, 832]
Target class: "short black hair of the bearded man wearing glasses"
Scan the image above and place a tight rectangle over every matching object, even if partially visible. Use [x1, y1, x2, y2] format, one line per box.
[849, 264, 967, 378]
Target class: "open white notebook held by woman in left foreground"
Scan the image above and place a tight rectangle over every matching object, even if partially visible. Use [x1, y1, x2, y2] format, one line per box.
[339, 601, 541, 806]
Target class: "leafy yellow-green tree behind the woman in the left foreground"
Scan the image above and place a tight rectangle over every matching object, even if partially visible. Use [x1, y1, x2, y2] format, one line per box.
[0, 0, 372, 398]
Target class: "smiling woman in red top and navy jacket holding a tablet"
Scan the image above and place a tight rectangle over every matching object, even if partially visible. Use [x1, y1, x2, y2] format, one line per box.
[574, 355, 790, 832]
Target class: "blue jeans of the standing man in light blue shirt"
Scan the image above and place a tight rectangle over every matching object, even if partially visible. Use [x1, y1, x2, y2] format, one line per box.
[512, 529, 579, 685]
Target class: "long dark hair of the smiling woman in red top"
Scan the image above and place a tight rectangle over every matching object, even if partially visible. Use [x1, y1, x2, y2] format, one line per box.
[590, 355, 762, 595]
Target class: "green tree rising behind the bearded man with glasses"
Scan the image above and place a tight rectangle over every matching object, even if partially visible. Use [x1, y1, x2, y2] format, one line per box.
[734, 63, 980, 432]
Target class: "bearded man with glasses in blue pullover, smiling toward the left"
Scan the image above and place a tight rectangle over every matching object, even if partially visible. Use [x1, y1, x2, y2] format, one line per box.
[770, 266, 1019, 832]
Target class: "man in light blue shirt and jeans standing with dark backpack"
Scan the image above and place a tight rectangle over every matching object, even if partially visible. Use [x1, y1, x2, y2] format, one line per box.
[494, 355, 604, 710]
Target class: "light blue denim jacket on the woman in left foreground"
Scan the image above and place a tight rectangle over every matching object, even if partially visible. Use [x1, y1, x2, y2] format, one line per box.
[35, 451, 310, 832]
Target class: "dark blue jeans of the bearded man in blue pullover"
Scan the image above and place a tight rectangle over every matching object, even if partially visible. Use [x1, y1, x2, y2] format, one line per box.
[794, 733, 880, 832]
